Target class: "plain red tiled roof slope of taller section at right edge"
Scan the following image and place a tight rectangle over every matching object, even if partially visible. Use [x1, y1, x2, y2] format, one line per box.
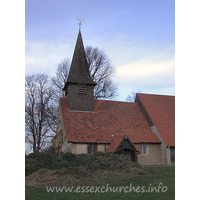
[137, 94, 175, 146]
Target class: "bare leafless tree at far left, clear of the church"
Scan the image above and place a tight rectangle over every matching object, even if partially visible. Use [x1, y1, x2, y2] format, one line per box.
[25, 74, 53, 152]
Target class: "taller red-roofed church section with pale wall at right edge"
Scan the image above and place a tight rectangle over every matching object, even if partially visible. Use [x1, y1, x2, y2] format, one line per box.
[135, 94, 175, 165]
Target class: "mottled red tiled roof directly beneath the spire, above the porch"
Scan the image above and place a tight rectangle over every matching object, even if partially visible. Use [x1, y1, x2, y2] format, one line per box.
[60, 97, 160, 143]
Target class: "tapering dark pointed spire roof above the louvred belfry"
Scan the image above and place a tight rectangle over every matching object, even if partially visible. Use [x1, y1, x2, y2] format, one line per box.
[64, 29, 96, 85]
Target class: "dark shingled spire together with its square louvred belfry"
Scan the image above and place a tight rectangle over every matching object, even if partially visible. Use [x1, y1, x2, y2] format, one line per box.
[63, 29, 96, 111]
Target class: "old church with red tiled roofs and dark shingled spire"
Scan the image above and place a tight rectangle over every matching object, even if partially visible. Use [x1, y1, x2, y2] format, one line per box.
[51, 29, 175, 166]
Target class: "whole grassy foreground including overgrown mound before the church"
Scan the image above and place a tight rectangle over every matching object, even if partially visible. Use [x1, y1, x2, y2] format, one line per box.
[25, 152, 175, 200]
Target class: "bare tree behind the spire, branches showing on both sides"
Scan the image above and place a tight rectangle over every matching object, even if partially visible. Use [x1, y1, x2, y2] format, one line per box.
[51, 46, 117, 99]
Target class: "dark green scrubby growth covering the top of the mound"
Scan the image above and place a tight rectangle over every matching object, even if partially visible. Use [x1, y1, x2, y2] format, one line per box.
[25, 152, 145, 177]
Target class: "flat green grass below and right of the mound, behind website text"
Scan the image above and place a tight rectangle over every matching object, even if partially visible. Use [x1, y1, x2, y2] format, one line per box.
[25, 167, 175, 200]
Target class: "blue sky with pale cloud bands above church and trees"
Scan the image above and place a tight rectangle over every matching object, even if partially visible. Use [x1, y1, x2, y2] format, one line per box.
[25, 0, 175, 101]
